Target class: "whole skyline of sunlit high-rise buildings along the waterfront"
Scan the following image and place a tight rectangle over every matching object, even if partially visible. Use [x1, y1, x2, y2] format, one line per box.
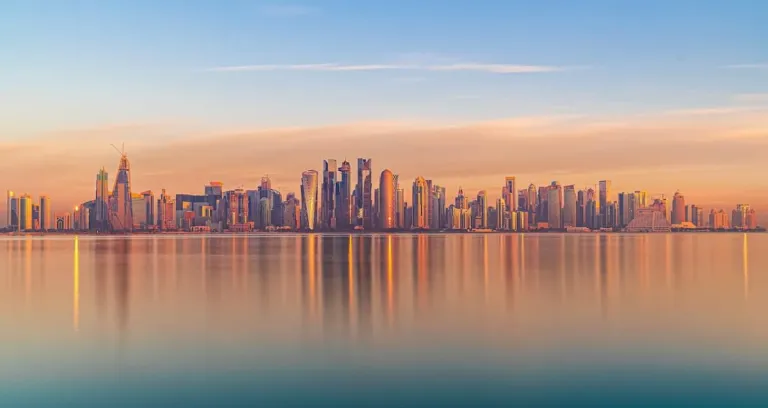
[7, 152, 758, 233]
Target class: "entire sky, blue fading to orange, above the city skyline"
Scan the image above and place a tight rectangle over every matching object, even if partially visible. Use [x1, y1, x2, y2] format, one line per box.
[0, 0, 768, 223]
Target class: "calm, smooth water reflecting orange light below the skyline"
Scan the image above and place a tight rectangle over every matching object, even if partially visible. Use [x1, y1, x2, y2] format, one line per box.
[0, 234, 768, 407]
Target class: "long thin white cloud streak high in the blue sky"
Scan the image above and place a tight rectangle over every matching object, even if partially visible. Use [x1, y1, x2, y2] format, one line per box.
[208, 63, 573, 74]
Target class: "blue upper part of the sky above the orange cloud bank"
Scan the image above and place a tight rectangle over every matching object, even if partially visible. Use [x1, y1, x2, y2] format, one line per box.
[0, 0, 768, 135]
